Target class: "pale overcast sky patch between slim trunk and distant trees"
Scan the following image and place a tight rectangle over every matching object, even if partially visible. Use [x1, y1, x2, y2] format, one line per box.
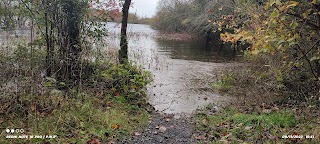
[129, 0, 159, 17]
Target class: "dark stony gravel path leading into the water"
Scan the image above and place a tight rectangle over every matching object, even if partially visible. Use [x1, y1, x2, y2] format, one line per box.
[131, 112, 195, 144]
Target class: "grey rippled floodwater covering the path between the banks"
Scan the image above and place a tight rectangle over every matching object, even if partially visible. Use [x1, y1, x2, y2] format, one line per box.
[107, 23, 238, 114]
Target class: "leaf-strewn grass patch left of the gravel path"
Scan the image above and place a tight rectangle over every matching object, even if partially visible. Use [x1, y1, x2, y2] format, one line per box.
[0, 94, 149, 143]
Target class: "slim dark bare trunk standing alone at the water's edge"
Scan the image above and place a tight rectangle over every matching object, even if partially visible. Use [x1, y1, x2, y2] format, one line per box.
[119, 0, 131, 64]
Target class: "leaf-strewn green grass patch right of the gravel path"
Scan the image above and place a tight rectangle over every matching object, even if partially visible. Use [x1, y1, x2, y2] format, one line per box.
[195, 107, 319, 143]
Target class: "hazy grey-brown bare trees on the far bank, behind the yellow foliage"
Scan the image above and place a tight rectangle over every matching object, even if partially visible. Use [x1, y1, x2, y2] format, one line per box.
[151, 0, 234, 36]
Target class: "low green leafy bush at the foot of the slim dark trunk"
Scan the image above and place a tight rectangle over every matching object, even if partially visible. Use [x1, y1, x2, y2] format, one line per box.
[94, 64, 152, 105]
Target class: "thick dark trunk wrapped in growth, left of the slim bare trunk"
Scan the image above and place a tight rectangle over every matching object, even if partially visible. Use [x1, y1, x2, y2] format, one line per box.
[58, 0, 82, 88]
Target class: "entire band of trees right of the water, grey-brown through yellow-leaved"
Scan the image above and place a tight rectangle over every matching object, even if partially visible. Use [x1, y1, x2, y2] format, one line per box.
[152, 0, 320, 101]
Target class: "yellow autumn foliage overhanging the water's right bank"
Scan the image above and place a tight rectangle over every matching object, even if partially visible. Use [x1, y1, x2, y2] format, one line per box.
[215, 0, 320, 97]
